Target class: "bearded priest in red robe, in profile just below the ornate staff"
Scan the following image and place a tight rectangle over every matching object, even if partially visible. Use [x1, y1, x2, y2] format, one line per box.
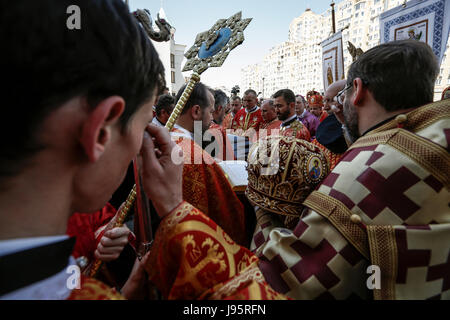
[171, 83, 251, 246]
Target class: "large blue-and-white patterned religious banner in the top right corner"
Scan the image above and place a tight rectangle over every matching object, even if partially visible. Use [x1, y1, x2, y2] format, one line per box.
[380, 0, 450, 63]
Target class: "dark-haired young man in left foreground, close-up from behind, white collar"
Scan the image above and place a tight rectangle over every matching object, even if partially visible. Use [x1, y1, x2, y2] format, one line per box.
[0, 0, 181, 299]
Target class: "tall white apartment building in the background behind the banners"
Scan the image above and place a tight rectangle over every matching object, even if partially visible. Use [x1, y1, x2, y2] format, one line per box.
[241, 0, 450, 100]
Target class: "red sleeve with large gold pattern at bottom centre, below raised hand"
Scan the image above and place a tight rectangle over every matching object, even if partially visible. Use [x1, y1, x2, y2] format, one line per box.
[146, 202, 286, 300]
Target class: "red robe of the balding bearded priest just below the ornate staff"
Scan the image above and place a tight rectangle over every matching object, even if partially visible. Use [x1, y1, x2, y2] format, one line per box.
[171, 126, 251, 246]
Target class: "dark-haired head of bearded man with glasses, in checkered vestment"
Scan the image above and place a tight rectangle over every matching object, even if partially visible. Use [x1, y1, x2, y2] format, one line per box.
[343, 41, 439, 144]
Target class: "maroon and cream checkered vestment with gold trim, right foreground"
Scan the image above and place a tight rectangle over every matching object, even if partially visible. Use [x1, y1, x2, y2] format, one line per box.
[251, 101, 450, 299]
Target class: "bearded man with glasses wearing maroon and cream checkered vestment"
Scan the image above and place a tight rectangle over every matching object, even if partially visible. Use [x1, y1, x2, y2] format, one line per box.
[252, 40, 450, 299]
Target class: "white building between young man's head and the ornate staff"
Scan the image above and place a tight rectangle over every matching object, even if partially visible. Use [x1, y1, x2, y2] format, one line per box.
[151, 8, 186, 94]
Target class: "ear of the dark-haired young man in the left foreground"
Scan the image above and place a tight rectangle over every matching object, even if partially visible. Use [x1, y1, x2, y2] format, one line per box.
[80, 96, 125, 162]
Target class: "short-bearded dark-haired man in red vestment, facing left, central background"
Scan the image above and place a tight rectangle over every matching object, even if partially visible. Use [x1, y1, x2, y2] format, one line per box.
[273, 89, 311, 142]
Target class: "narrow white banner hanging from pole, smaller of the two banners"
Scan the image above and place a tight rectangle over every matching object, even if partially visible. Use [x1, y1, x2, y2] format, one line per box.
[321, 31, 345, 91]
